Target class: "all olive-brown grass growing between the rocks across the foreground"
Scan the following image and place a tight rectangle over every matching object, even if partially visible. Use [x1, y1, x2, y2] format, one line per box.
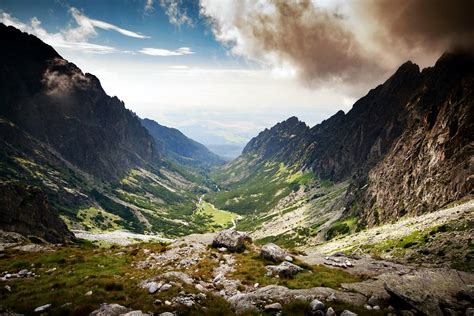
[0, 242, 376, 315]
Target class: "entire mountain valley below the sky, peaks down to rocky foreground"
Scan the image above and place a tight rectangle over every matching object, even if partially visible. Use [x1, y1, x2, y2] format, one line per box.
[0, 20, 474, 316]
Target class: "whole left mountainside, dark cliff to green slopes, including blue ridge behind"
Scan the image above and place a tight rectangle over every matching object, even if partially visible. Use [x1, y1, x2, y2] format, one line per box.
[0, 24, 220, 241]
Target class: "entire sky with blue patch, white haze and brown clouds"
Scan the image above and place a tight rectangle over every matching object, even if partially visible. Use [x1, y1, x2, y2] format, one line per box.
[0, 0, 474, 152]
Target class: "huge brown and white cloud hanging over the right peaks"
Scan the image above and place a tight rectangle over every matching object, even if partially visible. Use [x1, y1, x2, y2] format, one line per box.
[200, 0, 474, 86]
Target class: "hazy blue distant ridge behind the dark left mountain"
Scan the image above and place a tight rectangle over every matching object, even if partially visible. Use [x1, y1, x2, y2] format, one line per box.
[141, 119, 224, 167]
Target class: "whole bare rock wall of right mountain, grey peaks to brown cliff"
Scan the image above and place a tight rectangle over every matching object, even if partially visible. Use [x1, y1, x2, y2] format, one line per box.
[244, 53, 474, 225]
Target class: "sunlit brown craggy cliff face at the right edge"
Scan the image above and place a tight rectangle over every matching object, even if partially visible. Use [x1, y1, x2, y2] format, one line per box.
[364, 54, 474, 224]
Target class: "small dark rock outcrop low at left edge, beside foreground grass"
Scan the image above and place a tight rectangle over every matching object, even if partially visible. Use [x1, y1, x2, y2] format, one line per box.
[0, 183, 74, 243]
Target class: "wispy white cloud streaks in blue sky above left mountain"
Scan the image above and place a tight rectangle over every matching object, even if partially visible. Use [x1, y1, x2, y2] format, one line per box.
[0, 7, 148, 54]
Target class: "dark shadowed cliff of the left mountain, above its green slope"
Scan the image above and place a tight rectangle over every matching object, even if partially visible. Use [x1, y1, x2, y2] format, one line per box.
[0, 24, 159, 180]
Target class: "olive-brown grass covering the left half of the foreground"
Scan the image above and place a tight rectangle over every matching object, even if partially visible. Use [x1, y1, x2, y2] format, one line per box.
[0, 242, 230, 315]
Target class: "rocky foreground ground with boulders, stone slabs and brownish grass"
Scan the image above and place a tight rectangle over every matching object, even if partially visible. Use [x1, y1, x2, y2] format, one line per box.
[0, 230, 474, 316]
